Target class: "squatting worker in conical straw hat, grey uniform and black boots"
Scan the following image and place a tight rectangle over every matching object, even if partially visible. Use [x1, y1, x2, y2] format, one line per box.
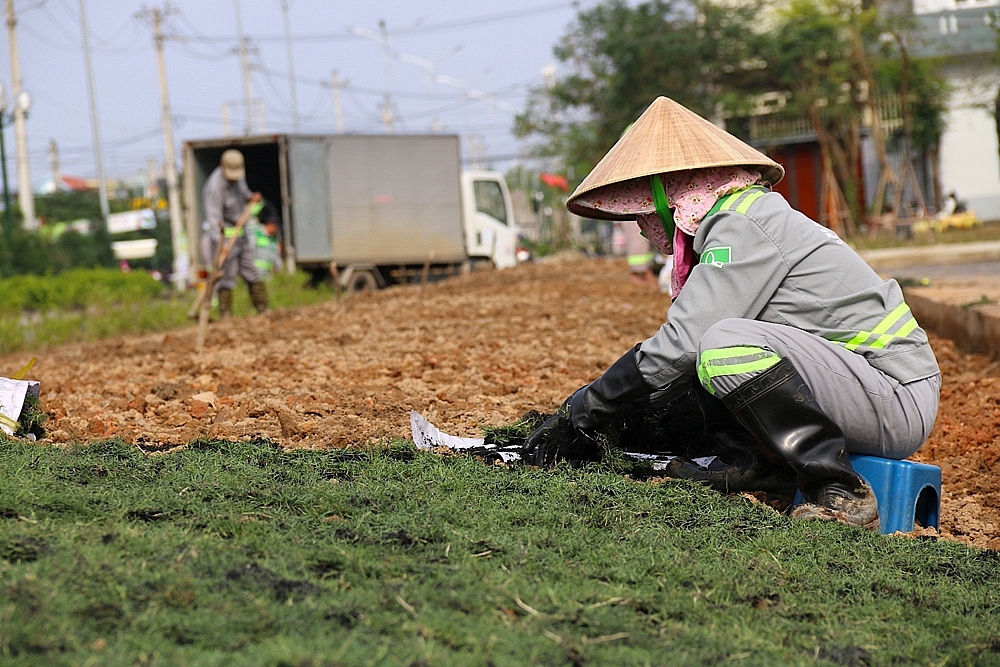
[526, 97, 941, 529]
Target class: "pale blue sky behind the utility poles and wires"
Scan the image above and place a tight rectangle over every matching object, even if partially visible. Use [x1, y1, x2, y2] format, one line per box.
[0, 0, 597, 190]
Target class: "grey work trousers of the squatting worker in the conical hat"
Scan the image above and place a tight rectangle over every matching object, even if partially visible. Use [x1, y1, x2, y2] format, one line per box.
[698, 319, 941, 459]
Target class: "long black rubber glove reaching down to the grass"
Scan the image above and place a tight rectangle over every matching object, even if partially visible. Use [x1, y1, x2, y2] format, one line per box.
[522, 345, 653, 465]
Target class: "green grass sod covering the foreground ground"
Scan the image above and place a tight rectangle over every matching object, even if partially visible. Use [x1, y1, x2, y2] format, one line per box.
[0, 440, 1000, 667]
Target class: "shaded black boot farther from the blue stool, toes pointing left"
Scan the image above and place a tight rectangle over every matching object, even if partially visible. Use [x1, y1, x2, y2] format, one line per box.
[666, 381, 796, 495]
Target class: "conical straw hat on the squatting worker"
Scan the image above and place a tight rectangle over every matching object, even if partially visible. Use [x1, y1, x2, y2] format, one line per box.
[566, 97, 785, 220]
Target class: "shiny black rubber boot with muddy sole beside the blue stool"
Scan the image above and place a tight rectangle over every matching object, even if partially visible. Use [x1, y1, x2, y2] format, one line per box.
[723, 359, 879, 530]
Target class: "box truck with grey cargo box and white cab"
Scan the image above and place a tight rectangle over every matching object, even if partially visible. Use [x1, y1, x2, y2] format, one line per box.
[183, 134, 518, 291]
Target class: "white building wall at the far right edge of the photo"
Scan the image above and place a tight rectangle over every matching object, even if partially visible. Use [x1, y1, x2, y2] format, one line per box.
[941, 62, 1000, 220]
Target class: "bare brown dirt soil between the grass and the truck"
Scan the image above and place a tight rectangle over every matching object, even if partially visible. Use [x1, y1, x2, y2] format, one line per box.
[0, 256, 1000, 549]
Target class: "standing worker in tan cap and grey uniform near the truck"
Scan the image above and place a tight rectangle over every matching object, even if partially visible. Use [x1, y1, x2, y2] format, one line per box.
[202, 148, 267, 317]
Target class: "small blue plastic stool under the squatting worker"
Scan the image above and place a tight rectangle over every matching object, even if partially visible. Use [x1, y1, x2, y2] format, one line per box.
[794, 454, 941, 535]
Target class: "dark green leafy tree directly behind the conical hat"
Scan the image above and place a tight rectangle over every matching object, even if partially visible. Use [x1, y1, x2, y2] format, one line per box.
[515, 0, 766, 185]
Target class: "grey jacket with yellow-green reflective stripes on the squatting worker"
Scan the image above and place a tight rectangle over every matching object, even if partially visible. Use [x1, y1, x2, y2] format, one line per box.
[636, 186, 940, 389]
